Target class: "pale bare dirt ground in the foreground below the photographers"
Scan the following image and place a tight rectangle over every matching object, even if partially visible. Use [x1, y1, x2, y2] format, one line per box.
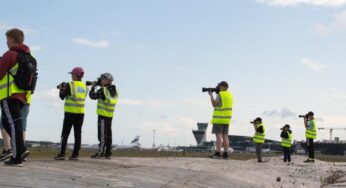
[0, 157, 346, 188]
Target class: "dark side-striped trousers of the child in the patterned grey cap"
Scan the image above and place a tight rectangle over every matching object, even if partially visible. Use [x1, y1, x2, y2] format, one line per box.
[97, 116, 112, 155]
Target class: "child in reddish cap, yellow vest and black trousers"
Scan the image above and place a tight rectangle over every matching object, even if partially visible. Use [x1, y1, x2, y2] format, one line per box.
[54, 67, 88, 160]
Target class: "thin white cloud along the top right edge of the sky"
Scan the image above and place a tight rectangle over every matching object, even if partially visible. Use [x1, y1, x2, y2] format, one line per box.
[256, 0, 346, 7]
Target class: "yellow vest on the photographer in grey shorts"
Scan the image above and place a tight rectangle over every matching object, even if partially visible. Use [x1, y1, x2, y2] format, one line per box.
[211, 91, 233, 125]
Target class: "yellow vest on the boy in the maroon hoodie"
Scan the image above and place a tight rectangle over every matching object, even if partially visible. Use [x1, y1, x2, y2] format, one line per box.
[0, 63, 25, 101]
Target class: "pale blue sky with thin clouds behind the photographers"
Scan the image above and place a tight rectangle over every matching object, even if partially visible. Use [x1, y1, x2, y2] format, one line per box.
[0, 0, 346, 147]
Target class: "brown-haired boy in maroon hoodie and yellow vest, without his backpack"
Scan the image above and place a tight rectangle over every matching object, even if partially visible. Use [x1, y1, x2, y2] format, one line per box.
[0, 28, 30, 167]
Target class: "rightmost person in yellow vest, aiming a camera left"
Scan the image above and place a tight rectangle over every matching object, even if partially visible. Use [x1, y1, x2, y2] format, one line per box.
[304, 111, 317, 163]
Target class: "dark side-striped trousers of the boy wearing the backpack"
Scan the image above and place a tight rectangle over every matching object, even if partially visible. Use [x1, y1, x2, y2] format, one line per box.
[1, 99, 26, 162]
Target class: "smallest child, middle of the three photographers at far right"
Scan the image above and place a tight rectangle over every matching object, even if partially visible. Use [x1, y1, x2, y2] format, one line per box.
[280, 124, 292, 164]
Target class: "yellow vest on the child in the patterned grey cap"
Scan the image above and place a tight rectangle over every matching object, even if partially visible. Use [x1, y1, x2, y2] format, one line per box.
[97, 87, 118, 118]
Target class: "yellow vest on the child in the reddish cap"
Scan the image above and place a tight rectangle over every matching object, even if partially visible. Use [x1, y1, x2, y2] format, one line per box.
[64, 81, 88, 114]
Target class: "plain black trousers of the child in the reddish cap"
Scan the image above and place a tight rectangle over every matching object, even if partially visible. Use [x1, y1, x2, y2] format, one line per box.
[60, 112, 84, 156]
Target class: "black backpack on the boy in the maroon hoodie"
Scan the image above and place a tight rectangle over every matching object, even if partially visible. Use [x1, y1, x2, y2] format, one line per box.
[8, 51, 38, 93]
